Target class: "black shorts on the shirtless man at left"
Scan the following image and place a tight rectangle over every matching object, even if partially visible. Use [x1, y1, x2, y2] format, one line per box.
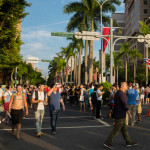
[11, 109, 24, 125]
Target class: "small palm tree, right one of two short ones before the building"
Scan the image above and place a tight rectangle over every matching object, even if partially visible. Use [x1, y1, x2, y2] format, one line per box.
[130, 48, 143, 83]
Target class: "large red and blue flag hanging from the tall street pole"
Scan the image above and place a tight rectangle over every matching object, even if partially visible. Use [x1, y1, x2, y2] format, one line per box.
[103, 27, 118, 52]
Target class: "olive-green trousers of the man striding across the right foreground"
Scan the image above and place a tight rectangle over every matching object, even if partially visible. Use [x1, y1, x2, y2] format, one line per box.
[105, 118, 132, 145]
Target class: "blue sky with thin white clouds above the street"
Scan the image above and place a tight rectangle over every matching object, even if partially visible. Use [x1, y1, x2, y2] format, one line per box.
[21, 0, 124, 77]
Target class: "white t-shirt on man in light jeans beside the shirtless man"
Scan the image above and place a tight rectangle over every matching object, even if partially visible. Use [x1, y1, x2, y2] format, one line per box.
[32, 91, 47, 110]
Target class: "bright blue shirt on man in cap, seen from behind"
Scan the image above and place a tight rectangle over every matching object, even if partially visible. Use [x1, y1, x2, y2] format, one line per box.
[127, 89, 138, 105]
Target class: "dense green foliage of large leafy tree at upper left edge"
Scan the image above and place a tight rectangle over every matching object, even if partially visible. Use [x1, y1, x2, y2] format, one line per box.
[0, 0, 30, 82]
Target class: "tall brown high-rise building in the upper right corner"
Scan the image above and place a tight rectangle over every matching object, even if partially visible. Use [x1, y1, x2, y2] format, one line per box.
[124, 0, 150, 57]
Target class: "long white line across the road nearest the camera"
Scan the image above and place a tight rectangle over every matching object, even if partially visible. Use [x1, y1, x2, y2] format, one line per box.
[0, 125, 106, 131]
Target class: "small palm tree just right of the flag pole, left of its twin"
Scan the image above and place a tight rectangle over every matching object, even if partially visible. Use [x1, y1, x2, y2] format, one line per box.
[119, 42, 130, 82]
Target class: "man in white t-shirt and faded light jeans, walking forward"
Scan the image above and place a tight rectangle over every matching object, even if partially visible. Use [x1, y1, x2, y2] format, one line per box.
[32, 84, 47, 137]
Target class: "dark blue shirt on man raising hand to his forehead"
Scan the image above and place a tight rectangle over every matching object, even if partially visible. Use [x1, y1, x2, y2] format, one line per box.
[49, 92, 62, 111]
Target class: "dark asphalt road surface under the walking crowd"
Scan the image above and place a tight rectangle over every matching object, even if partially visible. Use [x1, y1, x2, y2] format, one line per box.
[0, 104, 150, 150]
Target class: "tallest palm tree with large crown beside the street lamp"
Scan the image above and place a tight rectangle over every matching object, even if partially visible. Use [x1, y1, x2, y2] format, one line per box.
[64, 0, 121, 83]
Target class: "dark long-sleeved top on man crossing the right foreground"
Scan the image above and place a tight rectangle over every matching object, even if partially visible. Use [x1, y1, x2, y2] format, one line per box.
[114, 90, 128, 119]
